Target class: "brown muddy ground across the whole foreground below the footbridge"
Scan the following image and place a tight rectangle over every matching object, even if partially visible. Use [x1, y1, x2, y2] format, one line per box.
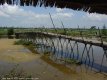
[0, 39, 107, 80]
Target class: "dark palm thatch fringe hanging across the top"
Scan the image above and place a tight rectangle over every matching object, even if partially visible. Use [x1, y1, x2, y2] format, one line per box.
[0, 0, 107, 14]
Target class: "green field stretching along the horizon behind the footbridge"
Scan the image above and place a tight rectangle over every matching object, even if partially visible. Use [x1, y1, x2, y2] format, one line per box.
[0, 28, 107, 41]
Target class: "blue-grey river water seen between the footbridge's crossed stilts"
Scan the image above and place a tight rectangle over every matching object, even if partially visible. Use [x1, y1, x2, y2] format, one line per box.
[35, 38, 107, 72]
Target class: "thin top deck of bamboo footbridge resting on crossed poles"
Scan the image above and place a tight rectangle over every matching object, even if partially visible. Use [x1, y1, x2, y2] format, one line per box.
[15, 32, 107, 49]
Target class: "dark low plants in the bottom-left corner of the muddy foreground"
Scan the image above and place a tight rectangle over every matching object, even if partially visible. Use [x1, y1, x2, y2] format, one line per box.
[0, 65, 32, 80]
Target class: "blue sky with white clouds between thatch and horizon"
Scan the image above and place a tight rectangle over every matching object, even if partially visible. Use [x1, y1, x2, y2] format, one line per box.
[0, 3, 107, 28]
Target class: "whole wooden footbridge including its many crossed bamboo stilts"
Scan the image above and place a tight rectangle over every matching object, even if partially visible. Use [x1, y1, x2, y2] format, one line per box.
[15, 32, 107, 72]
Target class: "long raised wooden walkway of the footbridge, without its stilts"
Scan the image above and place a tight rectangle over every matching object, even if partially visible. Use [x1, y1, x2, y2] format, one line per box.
[15, 32, 107, 49]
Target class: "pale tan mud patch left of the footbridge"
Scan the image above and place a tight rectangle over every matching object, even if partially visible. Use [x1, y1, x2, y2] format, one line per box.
[0, 39, 39, 62]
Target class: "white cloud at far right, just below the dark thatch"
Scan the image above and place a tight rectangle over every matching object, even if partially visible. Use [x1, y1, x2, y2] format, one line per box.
[84, 13, 107, 21]
